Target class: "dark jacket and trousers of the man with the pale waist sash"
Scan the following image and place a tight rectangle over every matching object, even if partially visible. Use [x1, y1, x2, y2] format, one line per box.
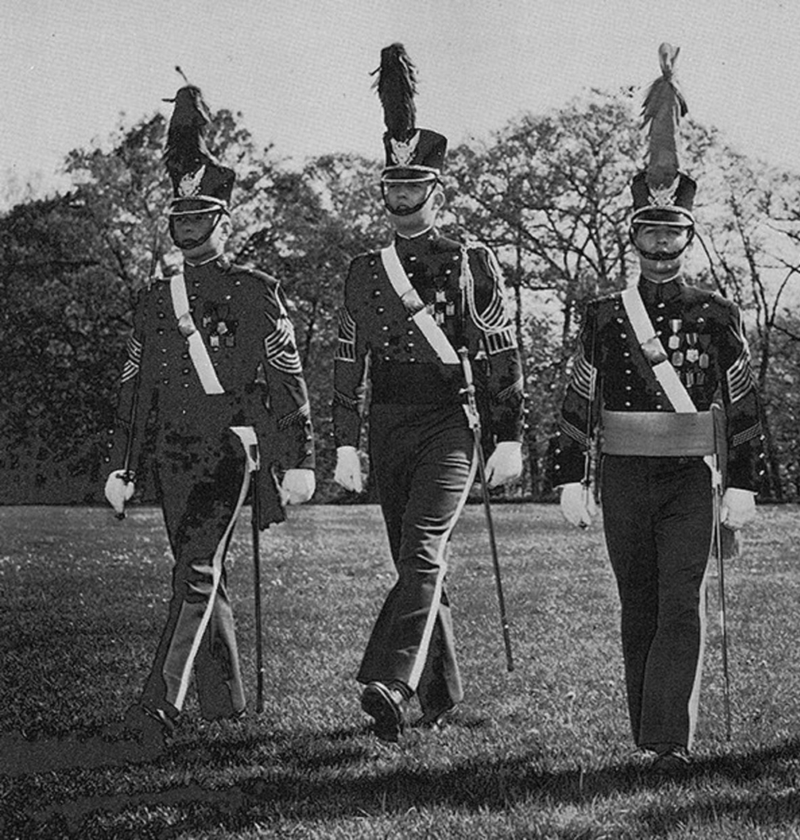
[555, 278, 762, 750]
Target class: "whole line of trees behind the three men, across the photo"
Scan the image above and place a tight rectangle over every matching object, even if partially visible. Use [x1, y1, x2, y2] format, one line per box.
[0, 91, 800, 503]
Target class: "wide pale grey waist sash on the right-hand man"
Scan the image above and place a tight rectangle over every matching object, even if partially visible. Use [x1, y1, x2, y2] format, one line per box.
[602, 409, 714, 458]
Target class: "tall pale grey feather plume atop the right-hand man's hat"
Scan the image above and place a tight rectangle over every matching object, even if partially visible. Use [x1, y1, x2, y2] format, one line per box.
[642, 43, 687, 190]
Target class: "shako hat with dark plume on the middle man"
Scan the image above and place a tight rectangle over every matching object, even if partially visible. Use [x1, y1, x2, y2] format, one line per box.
[372, 43, 447, 182]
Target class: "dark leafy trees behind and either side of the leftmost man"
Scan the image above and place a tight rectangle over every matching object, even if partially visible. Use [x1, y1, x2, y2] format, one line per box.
[0, 111, 386, 502]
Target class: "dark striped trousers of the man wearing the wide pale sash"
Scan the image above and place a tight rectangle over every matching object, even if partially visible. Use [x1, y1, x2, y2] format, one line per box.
[602, 456, 713, 749]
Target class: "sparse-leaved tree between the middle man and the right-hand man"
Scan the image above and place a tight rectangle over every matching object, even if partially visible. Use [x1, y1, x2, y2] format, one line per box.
[449, 93, 652, 498]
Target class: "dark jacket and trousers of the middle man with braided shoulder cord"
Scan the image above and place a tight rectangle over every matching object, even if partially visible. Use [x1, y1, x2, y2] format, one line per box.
[333, 229, 522, 719]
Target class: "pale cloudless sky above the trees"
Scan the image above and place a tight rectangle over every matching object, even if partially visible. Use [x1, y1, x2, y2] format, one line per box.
[0, 0, 800, 199]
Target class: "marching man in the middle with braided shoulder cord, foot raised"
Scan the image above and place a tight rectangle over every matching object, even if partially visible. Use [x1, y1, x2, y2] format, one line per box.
[333, 44, 522, 741]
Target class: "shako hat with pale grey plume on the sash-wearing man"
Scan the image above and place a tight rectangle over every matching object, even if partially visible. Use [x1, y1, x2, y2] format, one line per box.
[631, 43, 697, 228]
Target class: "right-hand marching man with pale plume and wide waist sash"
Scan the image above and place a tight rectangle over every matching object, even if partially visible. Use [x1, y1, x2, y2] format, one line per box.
[556, 44, 762, 772]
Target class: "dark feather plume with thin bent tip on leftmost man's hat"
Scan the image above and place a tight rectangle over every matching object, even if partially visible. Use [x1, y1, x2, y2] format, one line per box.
[164, 67, 219, 178]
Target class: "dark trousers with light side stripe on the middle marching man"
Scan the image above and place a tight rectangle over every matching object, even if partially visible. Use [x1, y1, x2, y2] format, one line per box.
[357, 405, 474, 713]
